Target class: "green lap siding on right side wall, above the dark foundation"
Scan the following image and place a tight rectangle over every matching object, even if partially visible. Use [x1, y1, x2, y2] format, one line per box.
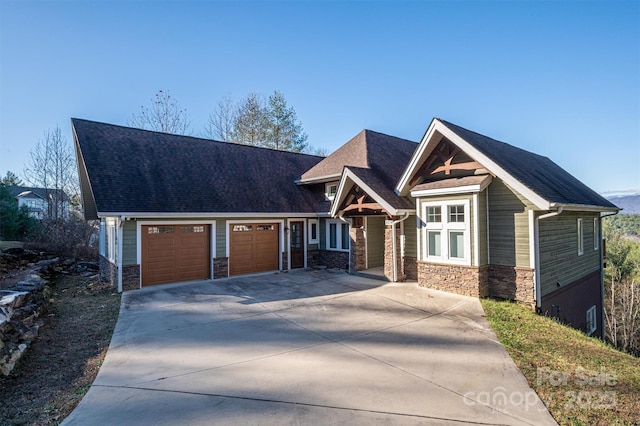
[538, 212, 601, 296]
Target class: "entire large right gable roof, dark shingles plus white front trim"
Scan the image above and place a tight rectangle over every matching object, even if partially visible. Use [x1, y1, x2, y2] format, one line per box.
[396, 118, 619, 211]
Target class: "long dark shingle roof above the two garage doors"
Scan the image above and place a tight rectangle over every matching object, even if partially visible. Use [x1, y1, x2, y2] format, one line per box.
[71, 118, 322, 219]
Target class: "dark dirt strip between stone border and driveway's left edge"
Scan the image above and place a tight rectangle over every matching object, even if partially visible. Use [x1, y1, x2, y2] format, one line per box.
[0, 275, 120, 425]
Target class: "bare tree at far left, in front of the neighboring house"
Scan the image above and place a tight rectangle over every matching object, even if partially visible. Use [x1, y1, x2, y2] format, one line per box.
[24, 126, 79, 220]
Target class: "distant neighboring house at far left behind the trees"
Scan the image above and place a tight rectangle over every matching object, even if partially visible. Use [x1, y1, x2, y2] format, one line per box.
[7, 186, 70, 220]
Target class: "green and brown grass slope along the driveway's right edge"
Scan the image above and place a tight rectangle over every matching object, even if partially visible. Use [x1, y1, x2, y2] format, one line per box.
[482, 300, 640, 425]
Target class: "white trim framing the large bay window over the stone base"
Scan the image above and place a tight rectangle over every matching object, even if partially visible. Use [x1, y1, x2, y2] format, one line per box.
[420, 199, 471, 266]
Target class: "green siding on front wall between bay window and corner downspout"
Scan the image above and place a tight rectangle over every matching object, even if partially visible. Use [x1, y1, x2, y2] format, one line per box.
[487, 179, 534, 268]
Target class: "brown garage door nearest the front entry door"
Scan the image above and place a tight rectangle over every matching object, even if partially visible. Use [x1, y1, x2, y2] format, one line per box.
[229, 223, 280, 275]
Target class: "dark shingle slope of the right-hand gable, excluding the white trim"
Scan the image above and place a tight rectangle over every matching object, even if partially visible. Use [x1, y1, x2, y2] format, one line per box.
[440, 120, 617, 208]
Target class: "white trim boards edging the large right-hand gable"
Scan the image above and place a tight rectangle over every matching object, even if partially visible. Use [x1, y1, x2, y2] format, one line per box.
[396, 118, 551, 210]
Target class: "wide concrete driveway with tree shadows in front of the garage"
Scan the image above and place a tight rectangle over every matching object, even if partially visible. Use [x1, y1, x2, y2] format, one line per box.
[63, 271, 555, 425]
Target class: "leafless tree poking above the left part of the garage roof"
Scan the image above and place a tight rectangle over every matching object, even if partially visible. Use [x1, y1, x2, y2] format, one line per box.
[129, 90, 191, 135]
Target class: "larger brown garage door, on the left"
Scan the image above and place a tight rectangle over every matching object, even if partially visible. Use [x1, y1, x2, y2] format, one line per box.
[142, 225, 210, 286]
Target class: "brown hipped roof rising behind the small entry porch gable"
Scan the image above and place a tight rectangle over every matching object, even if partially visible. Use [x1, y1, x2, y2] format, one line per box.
[300, 129, 418, 187]
